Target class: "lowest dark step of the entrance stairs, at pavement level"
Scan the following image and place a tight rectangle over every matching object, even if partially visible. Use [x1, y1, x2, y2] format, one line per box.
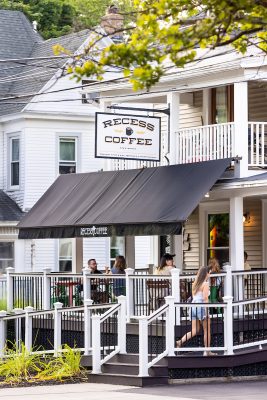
[88, 373, 168, 387]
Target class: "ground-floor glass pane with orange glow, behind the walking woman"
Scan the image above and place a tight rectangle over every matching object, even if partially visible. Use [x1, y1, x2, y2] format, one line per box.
[207, 213, 229, 267]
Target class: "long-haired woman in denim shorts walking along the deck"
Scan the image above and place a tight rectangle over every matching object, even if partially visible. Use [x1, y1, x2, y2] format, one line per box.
[176, 267, 216, 356]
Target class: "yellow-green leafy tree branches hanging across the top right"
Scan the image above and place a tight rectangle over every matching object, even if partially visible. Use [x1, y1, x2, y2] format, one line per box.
[69, 0, 267, 89]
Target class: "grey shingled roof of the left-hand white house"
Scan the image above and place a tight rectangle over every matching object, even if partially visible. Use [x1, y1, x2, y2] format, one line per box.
[0, 10, 90, 116]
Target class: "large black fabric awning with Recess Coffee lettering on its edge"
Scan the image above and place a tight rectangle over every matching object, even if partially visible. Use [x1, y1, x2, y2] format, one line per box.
[18, 159, 230, 239]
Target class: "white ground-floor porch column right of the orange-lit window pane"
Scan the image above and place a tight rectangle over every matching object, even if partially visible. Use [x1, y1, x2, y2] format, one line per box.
[230, 197, 244, 271]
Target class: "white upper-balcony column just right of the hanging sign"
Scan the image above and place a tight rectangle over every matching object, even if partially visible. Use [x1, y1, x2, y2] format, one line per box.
[167, 92, 180, 164]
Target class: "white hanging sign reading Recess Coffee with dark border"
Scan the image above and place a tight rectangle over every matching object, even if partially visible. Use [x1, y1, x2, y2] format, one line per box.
[95, 113, 160, 161]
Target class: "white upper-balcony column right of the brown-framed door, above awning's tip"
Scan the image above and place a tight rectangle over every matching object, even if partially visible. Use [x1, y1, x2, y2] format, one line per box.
[234, 82, 248, 177]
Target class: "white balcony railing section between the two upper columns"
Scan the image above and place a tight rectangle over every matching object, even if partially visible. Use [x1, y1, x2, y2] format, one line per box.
[177, 122, 235, 164]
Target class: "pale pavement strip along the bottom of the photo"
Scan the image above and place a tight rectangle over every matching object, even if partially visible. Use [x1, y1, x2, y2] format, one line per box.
[0, 378, 267, 400]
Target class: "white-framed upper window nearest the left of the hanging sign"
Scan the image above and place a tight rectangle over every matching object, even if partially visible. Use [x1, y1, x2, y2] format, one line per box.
[59, 137, 77, 174]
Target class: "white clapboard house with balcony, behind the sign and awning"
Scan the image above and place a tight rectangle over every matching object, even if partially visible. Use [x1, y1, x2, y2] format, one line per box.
[82, 43, 267, 269]
